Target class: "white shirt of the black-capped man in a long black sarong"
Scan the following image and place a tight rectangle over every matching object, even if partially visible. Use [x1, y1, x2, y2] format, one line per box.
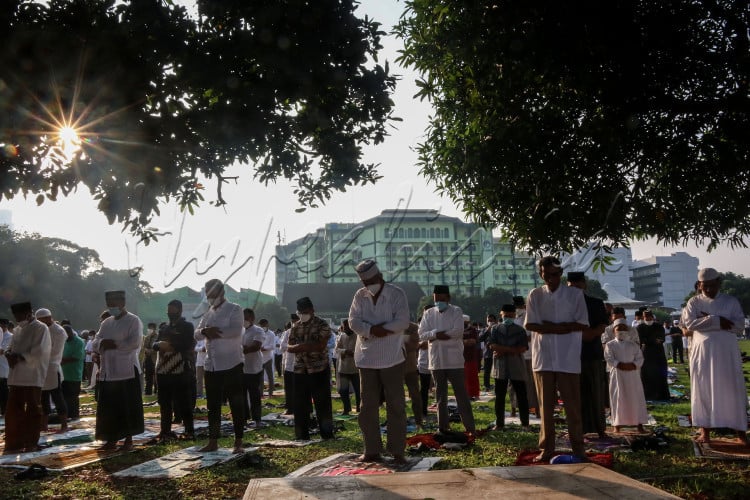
[94, 312, 143, 382]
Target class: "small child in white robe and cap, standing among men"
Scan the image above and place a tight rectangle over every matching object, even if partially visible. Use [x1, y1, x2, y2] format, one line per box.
[604, 318, 648, 432]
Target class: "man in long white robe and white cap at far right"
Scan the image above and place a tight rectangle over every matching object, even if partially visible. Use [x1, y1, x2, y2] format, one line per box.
[682, 267, 747, 444]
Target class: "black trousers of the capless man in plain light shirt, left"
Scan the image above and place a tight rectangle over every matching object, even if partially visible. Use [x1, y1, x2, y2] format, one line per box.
[205, 363, 245, 439]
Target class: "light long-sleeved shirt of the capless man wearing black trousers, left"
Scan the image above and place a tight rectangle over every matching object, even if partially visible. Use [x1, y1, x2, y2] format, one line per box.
[195, 300, 245, 372]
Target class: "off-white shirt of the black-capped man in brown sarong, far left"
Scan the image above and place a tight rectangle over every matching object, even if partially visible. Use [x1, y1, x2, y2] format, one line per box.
[8, 319, 52, 388]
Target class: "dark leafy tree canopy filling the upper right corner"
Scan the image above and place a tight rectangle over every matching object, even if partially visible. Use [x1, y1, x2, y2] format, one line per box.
[396, 0, 750, 252]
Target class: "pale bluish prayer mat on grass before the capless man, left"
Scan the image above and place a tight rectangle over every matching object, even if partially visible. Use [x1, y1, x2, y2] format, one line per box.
[112, 446, 258, 479]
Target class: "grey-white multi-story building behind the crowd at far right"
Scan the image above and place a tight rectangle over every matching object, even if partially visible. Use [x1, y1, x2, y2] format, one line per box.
[631, 252, 698, 309]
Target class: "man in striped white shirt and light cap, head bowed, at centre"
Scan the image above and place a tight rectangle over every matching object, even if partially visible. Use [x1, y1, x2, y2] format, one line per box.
[349, 259, 409, 463]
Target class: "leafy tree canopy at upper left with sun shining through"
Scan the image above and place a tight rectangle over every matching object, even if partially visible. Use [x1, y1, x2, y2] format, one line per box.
[0, 0, 395, 242]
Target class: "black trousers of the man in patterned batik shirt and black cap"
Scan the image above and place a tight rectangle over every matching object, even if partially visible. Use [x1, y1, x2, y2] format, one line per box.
[294, 367, 333, 440]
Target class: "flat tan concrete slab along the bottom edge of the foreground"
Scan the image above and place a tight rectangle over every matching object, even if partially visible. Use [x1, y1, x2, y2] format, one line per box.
[244, 464, 679, 500]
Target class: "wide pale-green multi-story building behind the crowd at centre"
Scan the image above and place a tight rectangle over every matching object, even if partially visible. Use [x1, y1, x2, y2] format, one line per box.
[276, 209, 539, 300]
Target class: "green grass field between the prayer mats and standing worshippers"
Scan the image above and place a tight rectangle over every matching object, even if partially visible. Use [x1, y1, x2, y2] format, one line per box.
[0, 341, 750, 499]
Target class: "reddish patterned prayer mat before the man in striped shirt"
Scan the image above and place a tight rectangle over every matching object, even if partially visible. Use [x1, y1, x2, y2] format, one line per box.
[286, 453, 441, 477]
